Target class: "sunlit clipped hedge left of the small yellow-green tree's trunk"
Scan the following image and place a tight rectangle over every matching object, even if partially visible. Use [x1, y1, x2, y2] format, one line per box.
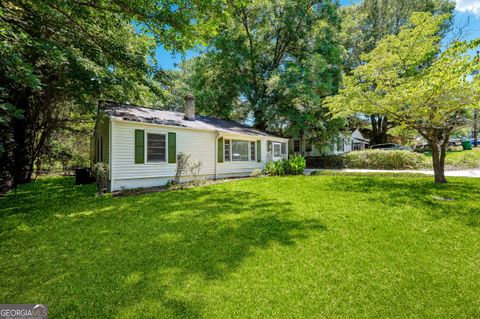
[343, 150, 424, 170]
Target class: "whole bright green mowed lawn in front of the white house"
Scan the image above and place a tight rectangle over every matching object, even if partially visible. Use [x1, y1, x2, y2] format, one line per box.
[0, 174, 480, 318]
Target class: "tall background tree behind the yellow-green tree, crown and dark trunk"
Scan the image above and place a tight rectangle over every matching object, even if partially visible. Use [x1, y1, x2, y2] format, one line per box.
[342, 0, 455, 144]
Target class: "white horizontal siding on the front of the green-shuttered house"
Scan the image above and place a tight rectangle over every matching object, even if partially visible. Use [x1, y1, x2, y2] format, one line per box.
[111, 121, 286, 190]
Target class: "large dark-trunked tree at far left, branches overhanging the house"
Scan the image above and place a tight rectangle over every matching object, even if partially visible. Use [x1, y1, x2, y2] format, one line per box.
[0, 0, 223, 188]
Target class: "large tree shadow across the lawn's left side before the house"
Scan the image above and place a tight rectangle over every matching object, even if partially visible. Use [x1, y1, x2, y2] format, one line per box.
[0, 179, 326, 318]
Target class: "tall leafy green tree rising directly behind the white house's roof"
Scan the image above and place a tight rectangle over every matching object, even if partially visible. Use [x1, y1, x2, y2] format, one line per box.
[184, 0, 342, 145]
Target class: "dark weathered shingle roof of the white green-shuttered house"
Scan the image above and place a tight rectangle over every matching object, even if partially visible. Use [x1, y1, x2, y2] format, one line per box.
[100, 102, 284, 137]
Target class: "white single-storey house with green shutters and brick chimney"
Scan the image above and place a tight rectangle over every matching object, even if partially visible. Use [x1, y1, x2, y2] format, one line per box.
[91, 95, 288, 191]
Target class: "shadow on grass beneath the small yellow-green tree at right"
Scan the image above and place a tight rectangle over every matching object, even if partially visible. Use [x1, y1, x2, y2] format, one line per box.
[318, 174, 480, 227]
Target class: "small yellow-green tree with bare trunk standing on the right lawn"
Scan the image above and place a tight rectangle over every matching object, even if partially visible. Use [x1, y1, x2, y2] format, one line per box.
[328, 13, 480, 183]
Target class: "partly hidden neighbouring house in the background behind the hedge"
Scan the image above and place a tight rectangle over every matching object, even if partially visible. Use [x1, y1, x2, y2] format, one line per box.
[289, 129, 369, 156]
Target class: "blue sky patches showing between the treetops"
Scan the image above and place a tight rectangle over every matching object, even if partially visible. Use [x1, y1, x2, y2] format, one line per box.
[156, 0, 480, 69]
